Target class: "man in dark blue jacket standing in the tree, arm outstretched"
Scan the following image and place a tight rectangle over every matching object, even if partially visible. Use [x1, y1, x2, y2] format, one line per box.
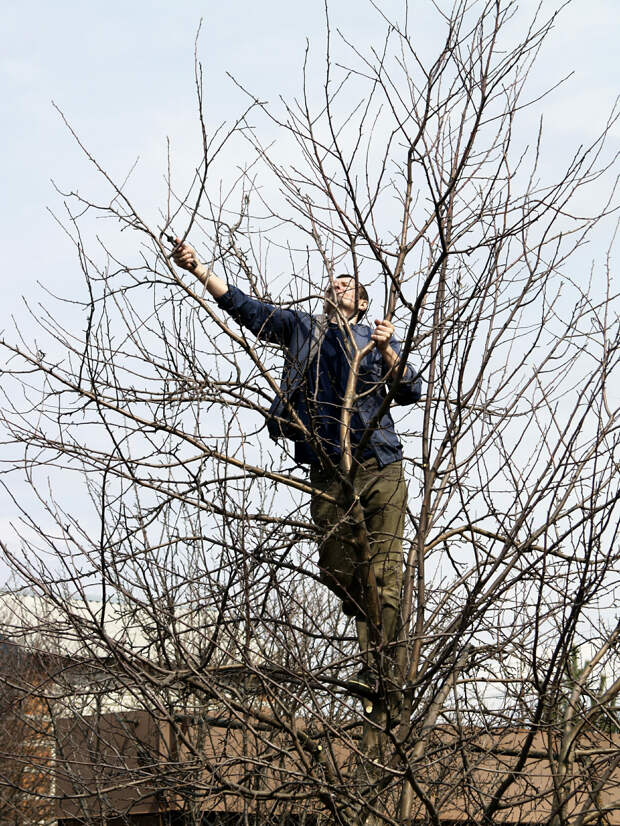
[173, 244, 421, 693]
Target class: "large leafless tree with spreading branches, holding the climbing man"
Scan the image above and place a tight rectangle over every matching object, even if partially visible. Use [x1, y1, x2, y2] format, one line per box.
[3, 0, 620, 826]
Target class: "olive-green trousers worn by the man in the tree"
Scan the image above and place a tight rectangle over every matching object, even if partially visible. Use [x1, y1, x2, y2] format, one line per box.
[310, 459, 407, 624]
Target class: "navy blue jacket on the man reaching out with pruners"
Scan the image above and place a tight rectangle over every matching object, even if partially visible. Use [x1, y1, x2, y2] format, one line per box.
[217, 284, 422, 467]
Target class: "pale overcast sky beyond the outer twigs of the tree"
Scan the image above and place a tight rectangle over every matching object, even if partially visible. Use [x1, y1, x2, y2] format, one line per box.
[0, 0, 620, 576]
